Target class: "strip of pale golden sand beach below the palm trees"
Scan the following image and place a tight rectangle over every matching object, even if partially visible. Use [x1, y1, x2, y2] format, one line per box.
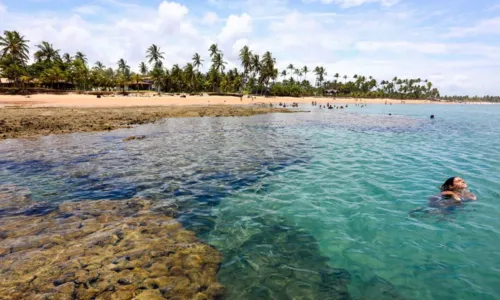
[0, 93, 498, 108]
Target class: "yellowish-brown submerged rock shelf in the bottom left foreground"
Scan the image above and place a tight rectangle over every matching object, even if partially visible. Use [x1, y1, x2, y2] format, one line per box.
[0, 194, 223, 299]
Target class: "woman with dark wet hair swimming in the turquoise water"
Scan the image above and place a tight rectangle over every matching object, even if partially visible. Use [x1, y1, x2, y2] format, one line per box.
[429, 177, 477, 207]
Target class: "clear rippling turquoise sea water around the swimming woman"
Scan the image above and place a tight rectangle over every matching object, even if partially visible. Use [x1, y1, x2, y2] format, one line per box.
[0, 105, 500, 299]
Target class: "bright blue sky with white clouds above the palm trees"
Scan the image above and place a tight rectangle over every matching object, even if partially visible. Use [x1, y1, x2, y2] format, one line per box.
[0, 0, 500, 96]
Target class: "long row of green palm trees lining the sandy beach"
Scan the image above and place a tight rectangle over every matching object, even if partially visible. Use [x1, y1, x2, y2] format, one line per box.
[0, 31, 446, 99]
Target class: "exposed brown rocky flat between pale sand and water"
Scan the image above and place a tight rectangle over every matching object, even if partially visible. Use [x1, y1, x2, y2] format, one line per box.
[0, 105, 289, 140]
